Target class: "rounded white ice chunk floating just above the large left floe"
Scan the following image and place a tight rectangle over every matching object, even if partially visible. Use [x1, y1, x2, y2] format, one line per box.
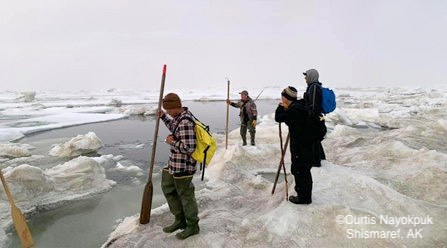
[49, 132, 103, 157]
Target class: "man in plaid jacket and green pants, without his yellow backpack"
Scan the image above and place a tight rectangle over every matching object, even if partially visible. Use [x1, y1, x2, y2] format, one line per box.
[158, 93, 200, 239]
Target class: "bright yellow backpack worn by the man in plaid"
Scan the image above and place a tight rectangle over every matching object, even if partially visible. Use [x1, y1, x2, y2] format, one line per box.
[174, 114, 217, 181]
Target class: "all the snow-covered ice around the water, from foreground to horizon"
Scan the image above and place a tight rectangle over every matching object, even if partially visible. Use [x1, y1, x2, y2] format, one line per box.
[0, 87, 447, 247]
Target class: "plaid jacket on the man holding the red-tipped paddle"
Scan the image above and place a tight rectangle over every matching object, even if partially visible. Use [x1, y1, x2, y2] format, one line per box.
[161, 107, 197, 176]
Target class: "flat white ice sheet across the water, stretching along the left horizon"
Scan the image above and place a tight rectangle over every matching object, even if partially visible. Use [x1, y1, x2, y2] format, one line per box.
[0, 88, 272, 142]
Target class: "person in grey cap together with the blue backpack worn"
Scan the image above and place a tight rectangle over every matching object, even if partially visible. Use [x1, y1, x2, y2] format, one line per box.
[302, 69, 335, 167]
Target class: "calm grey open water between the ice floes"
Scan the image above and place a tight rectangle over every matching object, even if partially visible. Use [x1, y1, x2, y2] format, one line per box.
[7, 100, 278, 248]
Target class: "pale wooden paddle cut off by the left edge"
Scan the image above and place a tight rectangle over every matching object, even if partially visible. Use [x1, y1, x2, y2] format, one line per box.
[0, 169, 34, 248]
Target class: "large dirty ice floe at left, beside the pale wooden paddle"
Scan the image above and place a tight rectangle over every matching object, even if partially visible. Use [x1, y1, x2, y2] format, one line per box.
[0, 157, 115, 246]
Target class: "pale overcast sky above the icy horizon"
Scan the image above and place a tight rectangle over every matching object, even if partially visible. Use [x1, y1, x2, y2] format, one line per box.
[0, 0, 447, 91]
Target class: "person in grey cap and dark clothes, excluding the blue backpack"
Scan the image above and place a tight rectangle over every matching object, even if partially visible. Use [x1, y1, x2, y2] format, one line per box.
[303, 69, 327, 167]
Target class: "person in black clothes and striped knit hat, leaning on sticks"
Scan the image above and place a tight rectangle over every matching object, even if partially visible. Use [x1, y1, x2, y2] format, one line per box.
[275, 86, 315, 204]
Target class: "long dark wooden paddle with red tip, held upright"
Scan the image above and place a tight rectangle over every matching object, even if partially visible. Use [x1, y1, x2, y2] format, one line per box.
[140, 65, 166, 224]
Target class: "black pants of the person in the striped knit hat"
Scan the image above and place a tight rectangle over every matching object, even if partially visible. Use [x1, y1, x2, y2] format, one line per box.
[290, 151, 313, 200]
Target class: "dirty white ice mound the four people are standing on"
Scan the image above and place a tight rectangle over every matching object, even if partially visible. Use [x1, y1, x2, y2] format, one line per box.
[103, 111, 447, 247]
